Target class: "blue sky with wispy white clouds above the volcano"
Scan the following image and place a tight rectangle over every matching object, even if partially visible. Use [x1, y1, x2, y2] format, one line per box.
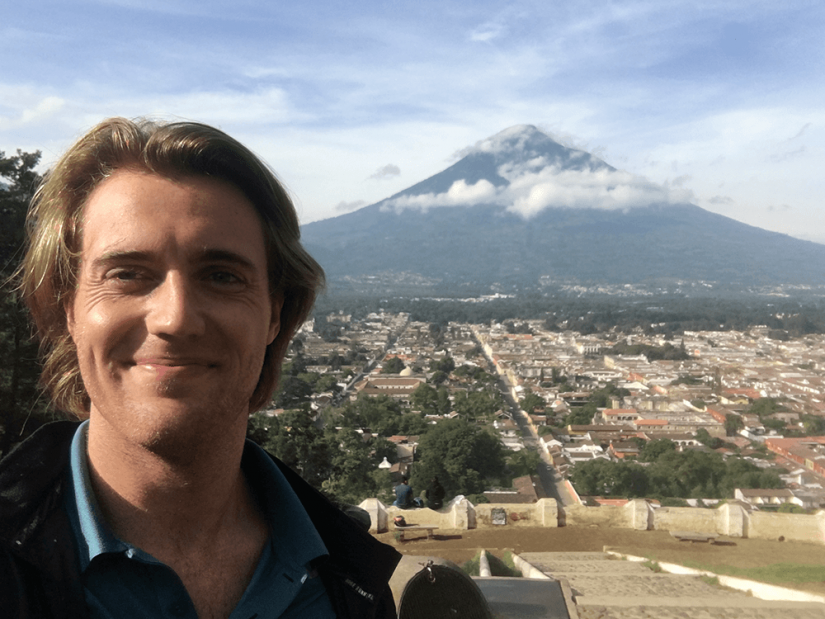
[0, 0, 825, 243]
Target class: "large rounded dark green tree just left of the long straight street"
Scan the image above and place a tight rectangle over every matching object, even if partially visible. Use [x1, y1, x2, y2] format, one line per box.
[412, 419, 505, 496]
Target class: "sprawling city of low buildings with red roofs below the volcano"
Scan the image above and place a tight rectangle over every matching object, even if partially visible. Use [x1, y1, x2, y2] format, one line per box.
[258, 312, 825, 512]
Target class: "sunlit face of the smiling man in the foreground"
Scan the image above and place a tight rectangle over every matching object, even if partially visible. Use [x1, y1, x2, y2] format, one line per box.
[66, 169, 280, 450]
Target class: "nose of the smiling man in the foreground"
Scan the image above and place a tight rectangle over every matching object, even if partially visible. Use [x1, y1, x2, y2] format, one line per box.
[146, 271, 204, 337]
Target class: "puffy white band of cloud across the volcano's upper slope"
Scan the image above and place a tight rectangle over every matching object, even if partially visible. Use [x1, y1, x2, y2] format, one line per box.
[382, 159, 694, 218]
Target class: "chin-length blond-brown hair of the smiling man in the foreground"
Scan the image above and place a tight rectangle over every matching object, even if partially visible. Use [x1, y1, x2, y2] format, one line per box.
[18, 118, 324, 419]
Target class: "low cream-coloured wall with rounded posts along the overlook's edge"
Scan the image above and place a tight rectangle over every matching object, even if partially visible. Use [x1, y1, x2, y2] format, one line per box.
[360, 497, 825, 544]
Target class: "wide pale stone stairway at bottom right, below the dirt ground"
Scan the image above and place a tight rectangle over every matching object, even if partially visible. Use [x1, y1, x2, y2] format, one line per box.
[521, 552, 825, 619]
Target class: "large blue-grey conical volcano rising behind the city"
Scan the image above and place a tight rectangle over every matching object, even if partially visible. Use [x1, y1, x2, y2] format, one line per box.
[302, 125, 825, 287]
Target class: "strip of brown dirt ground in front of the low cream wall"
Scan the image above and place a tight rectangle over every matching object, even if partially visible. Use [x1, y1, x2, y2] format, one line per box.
[376, 527, 825, 594]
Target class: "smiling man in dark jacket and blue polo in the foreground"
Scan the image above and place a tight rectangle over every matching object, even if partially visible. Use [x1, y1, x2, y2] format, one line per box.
[0, 119, 399, 619]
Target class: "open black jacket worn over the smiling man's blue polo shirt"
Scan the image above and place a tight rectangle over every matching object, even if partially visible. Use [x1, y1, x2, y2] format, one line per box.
[0, 421, 401, 619]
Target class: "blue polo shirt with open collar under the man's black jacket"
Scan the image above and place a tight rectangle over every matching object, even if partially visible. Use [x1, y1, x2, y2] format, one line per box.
[66, 421, 335, 619]
